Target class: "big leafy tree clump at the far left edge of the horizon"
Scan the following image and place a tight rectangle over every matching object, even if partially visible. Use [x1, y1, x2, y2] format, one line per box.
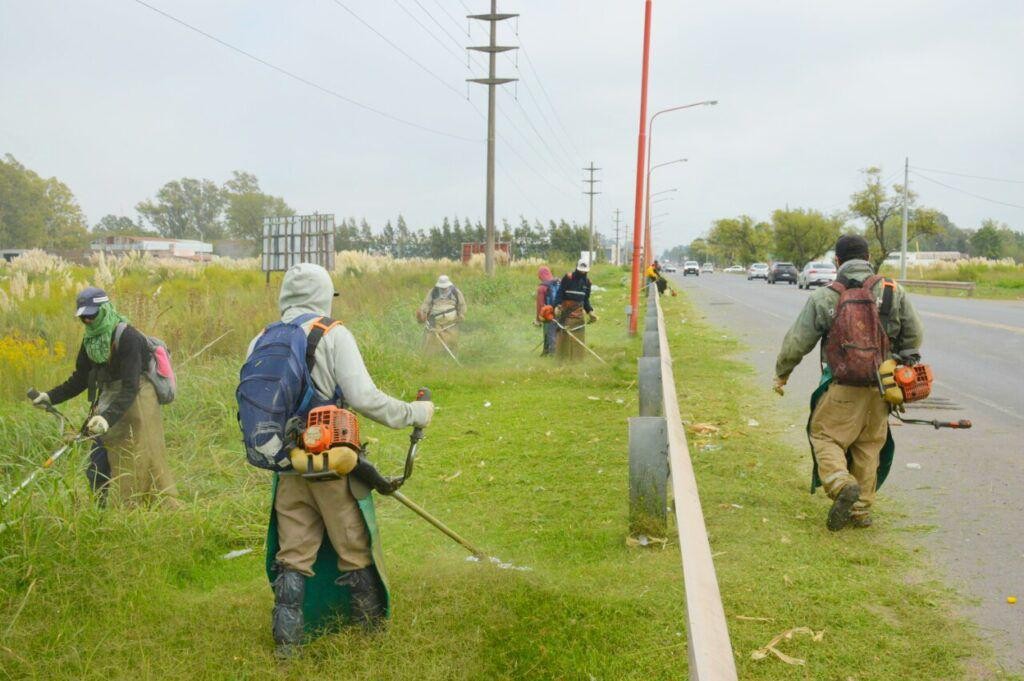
[0, 154, 88, 250]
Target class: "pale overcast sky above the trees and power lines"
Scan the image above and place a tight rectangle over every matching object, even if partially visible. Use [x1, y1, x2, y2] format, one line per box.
[0, 0, 1024, 250]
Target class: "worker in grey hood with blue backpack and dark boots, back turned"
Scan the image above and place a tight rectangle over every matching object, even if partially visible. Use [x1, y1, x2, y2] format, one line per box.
[239, 263, 434, 657]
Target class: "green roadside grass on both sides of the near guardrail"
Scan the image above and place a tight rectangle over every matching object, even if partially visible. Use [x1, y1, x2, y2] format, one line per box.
[0, 268, 991, 680]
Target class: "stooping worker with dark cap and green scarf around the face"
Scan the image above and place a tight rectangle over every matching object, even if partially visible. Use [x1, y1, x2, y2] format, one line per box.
[32, 287, 177, 505]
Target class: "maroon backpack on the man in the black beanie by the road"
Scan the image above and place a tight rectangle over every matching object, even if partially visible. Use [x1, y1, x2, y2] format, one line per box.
[825, 274, 895, 385]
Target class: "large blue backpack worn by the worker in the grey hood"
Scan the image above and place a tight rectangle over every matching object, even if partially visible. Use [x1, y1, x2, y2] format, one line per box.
[234, 314, 340, 472]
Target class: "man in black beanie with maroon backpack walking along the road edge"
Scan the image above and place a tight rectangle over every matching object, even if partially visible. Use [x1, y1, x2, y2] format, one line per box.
[774, 235, 924, 531]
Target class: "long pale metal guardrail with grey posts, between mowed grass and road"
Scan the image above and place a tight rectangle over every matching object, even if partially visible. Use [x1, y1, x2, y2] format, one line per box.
[630, 287, 737, 681]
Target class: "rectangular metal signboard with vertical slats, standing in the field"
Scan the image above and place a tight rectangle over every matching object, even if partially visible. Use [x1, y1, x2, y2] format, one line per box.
[261, 213, 334, 276]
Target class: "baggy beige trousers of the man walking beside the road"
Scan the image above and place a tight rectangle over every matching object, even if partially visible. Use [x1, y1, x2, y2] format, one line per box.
[810, 383, 889, 515]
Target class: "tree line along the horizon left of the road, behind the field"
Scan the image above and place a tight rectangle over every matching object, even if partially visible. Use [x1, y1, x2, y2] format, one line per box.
[0, 154, 600, 259]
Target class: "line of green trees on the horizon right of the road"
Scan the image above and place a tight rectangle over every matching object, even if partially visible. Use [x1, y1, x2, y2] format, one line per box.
[663, 167, 1024, 267]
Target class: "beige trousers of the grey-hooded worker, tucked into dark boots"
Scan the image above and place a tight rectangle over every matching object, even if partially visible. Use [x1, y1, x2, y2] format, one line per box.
[273, 475, 374, 577]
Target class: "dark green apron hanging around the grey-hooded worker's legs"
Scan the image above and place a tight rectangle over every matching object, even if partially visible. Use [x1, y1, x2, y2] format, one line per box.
[266, 473, 391, 636]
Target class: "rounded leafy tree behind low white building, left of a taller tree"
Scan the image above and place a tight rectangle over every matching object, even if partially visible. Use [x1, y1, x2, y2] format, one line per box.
[135, 177, 227, 242]
